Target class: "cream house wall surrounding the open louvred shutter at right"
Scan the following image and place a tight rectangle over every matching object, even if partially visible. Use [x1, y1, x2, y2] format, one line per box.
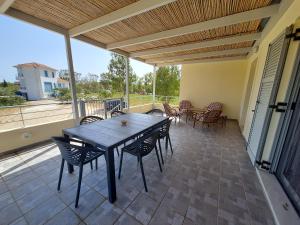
[243, 0, 300, 160]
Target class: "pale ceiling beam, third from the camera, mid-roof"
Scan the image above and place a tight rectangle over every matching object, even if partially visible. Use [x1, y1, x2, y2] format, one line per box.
[130, 33, 261, 57]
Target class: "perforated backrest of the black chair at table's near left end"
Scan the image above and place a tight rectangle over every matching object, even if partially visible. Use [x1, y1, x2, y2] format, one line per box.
[52, 137, 86, 166]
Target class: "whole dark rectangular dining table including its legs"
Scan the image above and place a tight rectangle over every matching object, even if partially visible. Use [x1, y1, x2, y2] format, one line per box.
[63, 113, 168, 203]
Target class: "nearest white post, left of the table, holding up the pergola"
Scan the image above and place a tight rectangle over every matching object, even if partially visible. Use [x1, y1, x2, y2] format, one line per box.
[65, 34, 79, 124]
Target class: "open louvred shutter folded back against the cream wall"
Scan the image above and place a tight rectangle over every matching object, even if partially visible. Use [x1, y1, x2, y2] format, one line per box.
[247, 27, 292, 164]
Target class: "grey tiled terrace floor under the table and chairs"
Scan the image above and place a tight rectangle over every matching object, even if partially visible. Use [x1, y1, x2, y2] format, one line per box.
[0, 122, 274, 225]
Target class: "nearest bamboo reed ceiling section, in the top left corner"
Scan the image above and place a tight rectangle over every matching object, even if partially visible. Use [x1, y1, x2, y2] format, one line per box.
[12, 0, 138, 29]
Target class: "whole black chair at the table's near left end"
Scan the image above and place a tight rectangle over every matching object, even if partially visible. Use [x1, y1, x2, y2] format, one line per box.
[52, 137, 105, 208]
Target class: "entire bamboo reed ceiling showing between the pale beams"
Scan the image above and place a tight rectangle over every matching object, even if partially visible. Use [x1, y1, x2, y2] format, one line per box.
[11, 0, 272, 64]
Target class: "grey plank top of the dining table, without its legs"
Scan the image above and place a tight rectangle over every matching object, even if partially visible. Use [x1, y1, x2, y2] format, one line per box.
[63, 113, 168, 149]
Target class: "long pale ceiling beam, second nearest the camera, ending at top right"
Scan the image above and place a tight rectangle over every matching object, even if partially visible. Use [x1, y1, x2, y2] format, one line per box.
[107, 4, 279, 49]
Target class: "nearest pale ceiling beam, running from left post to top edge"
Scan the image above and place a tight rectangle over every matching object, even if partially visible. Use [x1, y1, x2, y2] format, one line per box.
[69, 0, 175, 37]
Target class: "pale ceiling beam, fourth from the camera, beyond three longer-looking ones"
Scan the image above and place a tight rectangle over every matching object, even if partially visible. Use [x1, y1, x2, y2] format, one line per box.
[146, 47, 252, 63]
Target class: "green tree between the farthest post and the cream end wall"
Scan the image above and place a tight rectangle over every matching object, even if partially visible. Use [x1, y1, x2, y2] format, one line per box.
[156, 66, 180, 96]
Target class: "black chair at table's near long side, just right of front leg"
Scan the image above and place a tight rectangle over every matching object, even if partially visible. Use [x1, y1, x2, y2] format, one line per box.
[118, 130, 162, 192]
